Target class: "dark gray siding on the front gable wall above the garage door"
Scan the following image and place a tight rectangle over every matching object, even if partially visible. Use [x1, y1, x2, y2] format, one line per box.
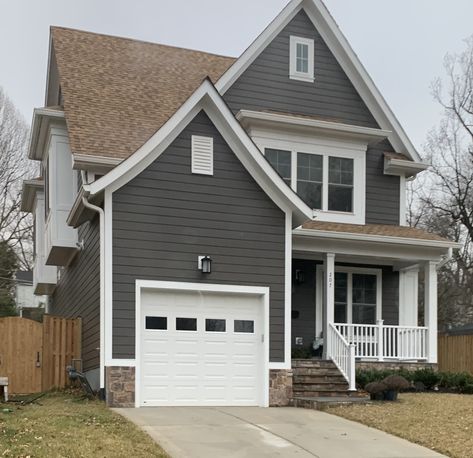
[113, 112, 285, 361]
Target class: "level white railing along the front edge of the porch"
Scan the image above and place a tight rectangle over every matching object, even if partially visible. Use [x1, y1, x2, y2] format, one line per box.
[334, 320, 428, 361]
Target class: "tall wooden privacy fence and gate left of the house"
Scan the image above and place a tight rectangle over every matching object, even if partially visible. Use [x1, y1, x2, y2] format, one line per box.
[0, 315, 82, 394]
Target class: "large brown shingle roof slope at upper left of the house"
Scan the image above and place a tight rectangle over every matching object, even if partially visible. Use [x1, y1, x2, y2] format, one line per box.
[51, 27, 235, 159]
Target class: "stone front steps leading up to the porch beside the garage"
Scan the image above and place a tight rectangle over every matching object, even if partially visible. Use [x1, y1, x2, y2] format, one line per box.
[292, 359, 369, 410]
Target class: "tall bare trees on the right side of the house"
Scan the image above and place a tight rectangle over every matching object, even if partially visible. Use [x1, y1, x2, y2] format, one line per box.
[408, 36, 473, 330]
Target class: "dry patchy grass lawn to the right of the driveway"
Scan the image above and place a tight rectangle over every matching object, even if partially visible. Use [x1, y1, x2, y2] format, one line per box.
[327, 393, 473, 458]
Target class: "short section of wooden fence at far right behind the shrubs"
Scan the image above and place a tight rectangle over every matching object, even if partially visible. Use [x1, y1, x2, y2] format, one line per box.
[438, 335, 473, 374]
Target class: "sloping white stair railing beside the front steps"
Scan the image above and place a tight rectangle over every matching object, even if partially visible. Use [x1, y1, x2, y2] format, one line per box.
[327, 323, 356, 391]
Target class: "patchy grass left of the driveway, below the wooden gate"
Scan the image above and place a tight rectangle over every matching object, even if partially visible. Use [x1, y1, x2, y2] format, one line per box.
[0, 393, 167, 458]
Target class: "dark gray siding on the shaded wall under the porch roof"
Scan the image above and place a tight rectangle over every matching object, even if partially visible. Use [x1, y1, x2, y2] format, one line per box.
[292, 259, 399, 347]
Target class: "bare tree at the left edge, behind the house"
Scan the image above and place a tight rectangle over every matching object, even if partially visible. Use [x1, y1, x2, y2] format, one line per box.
[0, 87, 35, 269]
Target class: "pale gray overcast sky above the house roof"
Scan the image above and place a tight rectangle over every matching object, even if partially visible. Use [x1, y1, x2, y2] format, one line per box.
[0, 0, 473, 149]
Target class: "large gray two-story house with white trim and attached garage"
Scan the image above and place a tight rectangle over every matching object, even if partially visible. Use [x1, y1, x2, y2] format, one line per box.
[23, 0, 457, 406]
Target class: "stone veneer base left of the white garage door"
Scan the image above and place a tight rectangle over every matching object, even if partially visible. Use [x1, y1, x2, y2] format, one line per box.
[105, 366, 135, 407]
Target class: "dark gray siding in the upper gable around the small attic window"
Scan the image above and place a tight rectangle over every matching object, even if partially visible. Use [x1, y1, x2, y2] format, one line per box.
[224, 11, 378, 127]
